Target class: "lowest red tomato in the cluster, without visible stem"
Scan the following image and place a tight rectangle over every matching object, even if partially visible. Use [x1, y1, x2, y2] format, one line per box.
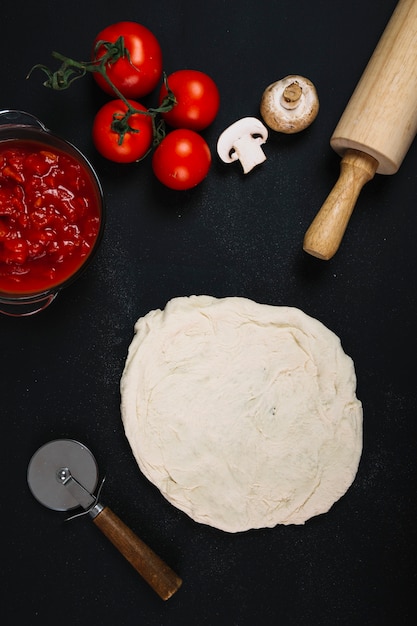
[152, 128, 211, 190]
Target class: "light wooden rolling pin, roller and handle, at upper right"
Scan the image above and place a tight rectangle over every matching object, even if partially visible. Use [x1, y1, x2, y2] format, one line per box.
[303, 0, 417, 260]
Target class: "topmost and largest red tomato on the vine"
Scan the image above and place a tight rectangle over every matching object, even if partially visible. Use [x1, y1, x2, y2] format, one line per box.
[92, 22, 162, 98]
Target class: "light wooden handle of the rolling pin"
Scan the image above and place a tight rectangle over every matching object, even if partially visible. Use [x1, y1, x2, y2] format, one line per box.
[303, 149, 378, 261]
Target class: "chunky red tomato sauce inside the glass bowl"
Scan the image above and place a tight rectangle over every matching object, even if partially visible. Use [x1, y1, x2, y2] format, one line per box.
[0, 140, 101, 294]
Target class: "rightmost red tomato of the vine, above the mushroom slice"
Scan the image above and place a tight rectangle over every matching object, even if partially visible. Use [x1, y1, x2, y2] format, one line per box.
[159, 70, 220, 131]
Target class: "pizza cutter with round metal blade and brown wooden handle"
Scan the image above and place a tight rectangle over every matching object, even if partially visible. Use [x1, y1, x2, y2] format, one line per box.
[27, 439, 182, 600]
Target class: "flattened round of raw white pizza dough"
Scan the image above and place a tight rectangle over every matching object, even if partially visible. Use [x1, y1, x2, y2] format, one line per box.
[121, 296, 362, 532]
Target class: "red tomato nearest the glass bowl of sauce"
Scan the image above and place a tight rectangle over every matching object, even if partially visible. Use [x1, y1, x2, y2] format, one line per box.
[92, 100, 153, 163]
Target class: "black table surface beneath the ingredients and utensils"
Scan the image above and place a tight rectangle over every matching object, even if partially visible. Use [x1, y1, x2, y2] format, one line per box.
[0, 0, 417, 626]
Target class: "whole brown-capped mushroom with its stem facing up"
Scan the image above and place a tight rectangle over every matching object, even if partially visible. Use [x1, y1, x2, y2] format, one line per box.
[260, 74, 319, 134]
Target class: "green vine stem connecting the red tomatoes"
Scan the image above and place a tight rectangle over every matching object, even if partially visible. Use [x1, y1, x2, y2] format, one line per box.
[26, 37, 177, 152]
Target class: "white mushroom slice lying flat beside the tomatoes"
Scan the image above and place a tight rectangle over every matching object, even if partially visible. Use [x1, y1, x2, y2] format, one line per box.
[217, 117, 268, 174]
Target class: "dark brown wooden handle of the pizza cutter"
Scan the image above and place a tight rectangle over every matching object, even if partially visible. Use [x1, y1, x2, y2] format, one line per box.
[93, 506, 182, 600]
